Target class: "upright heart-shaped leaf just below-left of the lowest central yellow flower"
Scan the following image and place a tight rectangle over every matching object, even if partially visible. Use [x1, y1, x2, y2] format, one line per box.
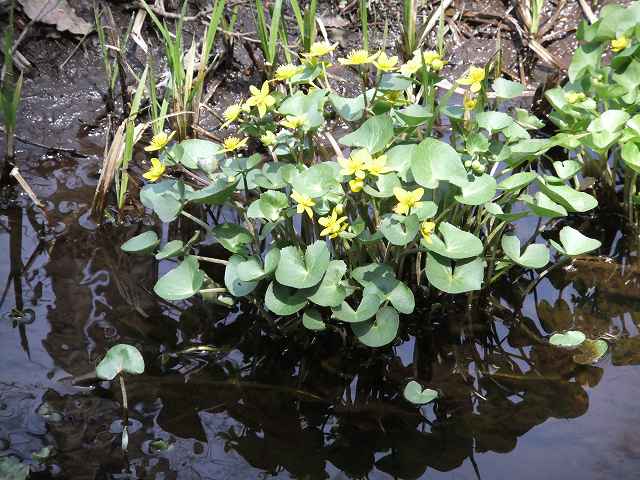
[276, 240, 329, 289]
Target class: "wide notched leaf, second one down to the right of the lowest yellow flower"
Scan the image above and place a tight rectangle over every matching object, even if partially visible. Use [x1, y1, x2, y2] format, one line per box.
[425, 253, 485, 294]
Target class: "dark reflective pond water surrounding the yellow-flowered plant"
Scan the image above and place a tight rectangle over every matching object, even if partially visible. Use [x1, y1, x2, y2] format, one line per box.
[0, 34, 640, 480]
